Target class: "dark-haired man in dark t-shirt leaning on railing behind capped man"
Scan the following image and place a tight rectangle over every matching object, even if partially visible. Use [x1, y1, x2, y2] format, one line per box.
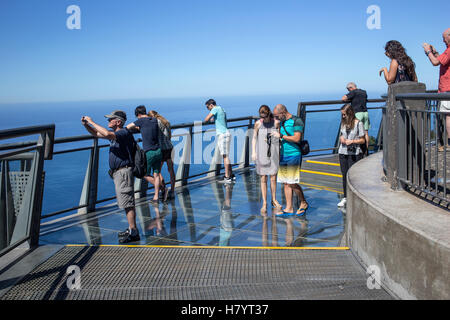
[127, 106, 162, 204]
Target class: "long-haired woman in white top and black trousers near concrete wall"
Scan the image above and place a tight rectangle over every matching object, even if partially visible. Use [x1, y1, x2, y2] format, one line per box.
[338, 104, 366, 207]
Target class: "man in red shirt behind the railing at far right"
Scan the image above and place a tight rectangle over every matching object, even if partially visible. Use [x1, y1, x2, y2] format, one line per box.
[423, 28, 450, 151]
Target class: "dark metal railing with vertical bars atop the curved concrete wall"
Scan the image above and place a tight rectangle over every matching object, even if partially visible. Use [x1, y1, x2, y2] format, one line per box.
[383, 87, 450, 209]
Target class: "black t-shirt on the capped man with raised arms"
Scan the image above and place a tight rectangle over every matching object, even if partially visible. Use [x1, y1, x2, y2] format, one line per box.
[109, 129, 134, 170]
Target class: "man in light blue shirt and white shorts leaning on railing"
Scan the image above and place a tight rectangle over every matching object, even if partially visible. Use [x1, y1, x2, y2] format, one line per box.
[205, 99, 234, 183]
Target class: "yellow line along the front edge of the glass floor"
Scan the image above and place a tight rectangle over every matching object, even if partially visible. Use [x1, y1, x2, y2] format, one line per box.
[66, 244, 350, 250]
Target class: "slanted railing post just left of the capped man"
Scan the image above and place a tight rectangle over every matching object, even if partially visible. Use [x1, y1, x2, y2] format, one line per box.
[77, 138, 99, 214]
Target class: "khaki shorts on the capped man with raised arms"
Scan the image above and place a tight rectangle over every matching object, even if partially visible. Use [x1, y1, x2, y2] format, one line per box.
[113, 168, 134, 209]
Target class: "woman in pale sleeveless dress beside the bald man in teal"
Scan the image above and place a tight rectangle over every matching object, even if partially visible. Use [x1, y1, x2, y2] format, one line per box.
[252, 105, 281, 215]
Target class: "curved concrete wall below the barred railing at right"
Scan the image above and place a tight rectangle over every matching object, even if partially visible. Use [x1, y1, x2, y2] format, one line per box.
[346, 153, 450, 299]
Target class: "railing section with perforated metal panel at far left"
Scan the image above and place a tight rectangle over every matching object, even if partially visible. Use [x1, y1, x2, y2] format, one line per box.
[0, 125, 55, 256]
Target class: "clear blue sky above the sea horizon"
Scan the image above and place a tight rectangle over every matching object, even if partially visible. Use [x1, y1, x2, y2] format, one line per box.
[0, 0, 450, 104]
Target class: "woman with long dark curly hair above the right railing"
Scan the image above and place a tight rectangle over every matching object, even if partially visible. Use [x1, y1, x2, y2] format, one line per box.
[380, 40, 417, 84]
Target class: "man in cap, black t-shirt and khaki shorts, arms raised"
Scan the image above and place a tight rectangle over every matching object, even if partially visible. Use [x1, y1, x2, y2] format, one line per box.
[81, 110, 140, 243]
